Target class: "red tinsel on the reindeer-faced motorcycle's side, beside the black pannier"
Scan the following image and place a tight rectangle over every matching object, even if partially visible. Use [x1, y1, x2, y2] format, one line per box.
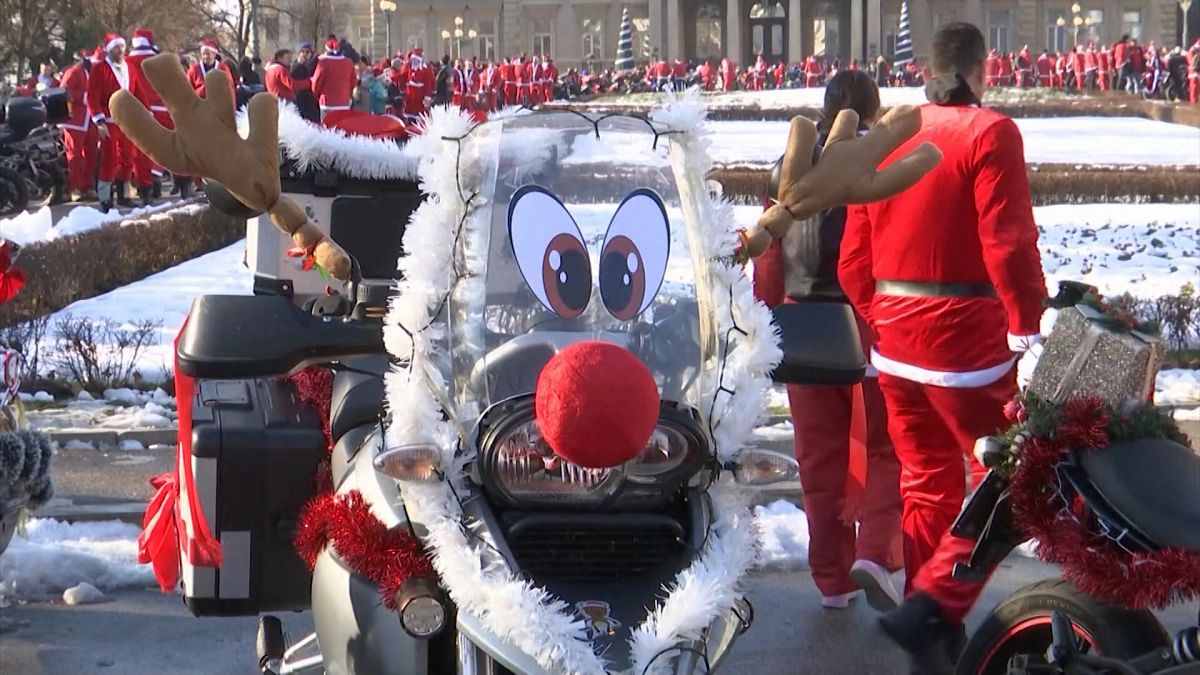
[288, 368, 436, 609]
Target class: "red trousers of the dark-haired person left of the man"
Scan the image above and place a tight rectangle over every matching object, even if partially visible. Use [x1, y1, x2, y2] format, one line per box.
[787, 378, 901, 596]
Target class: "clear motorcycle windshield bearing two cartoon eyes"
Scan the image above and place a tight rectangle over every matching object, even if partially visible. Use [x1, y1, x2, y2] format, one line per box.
[449, 113, 703, 424]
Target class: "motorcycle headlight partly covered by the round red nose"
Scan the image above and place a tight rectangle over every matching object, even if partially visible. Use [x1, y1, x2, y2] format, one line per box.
[479, 400, 708, 507]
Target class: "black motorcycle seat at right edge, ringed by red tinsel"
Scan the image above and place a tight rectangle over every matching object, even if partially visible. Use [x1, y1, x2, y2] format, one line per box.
[1079, 438, 1200, 550]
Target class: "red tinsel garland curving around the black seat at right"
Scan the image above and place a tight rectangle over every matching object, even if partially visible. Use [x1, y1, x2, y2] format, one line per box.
[1009, 398, 1200, 609]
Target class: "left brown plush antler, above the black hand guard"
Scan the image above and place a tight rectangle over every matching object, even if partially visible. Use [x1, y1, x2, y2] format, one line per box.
[110, 54, 350, 280]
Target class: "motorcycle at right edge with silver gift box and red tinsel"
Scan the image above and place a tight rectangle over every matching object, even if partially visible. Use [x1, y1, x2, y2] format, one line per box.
[953, 282, 1200, 675]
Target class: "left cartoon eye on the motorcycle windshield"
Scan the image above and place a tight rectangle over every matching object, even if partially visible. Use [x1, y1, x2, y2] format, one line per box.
[509, 185, 592, 318]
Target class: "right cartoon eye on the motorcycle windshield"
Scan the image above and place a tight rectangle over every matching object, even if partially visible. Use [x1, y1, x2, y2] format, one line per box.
[600, 190, 671, 321]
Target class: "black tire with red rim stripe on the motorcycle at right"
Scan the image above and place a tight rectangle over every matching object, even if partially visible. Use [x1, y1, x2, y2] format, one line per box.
[955, 579, 1171, 675]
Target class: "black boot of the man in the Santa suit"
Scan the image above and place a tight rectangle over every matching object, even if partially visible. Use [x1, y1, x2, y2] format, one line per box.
[880, 593, 966, 675]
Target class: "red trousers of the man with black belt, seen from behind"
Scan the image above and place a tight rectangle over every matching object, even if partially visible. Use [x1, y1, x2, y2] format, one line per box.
[880, 369, 1016, 621]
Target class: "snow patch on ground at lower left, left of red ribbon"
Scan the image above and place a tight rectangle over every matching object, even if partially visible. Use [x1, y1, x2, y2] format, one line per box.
[0, 518, 155, 601]
